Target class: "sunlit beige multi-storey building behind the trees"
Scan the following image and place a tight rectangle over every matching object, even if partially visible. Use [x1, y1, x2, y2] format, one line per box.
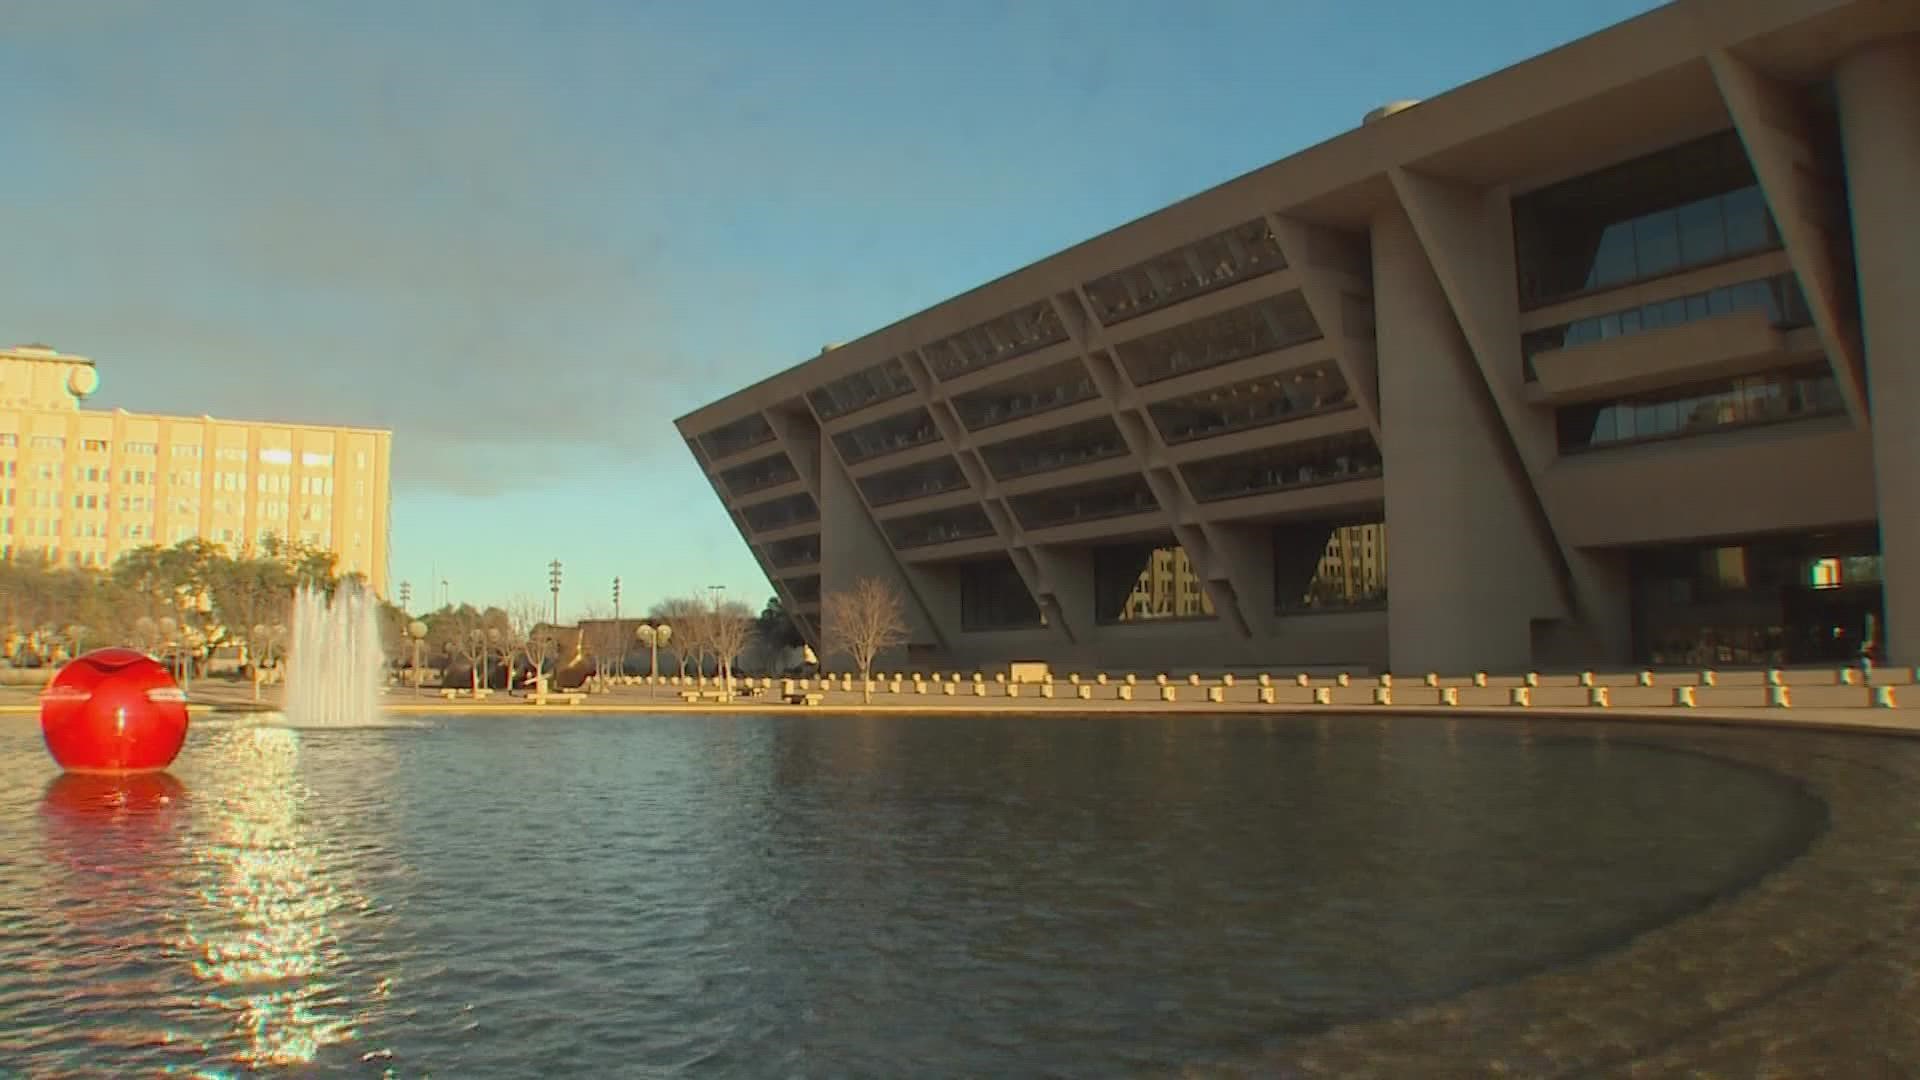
[0, 346, 394, 596]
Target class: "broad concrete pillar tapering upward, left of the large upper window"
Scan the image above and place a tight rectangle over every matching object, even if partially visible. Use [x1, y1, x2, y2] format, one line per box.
[1373, 209, 1557, 671]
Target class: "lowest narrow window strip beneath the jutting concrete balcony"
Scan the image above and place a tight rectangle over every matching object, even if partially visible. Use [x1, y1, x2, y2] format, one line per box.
[1557, 363, 1845, 454]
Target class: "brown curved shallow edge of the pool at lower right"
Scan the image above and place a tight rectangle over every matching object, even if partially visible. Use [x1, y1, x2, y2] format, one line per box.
[1181, 717, 1920, 1078]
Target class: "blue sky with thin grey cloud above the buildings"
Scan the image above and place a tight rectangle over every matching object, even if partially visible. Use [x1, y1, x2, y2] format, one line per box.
[0, 0, 1655, 611]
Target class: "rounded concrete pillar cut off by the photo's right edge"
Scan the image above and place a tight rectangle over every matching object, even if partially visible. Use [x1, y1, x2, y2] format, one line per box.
[1834, 35, 1920, 665]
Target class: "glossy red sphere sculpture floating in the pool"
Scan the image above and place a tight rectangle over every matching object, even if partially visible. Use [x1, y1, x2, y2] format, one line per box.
[40, 650, 186, 773]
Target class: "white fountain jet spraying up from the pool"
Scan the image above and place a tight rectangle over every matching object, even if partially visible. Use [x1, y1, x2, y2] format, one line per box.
[284, 584, 386, 726]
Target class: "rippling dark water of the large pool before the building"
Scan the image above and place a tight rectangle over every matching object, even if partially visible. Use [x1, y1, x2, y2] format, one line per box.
[0, 713, 1910, 1076]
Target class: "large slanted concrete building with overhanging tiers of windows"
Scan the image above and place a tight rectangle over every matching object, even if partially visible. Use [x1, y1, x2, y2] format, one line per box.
[678, 0, 1920, 671]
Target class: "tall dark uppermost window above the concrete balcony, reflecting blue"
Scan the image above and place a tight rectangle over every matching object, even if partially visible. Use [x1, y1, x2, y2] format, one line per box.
[1513, 131, 1780, 307]
